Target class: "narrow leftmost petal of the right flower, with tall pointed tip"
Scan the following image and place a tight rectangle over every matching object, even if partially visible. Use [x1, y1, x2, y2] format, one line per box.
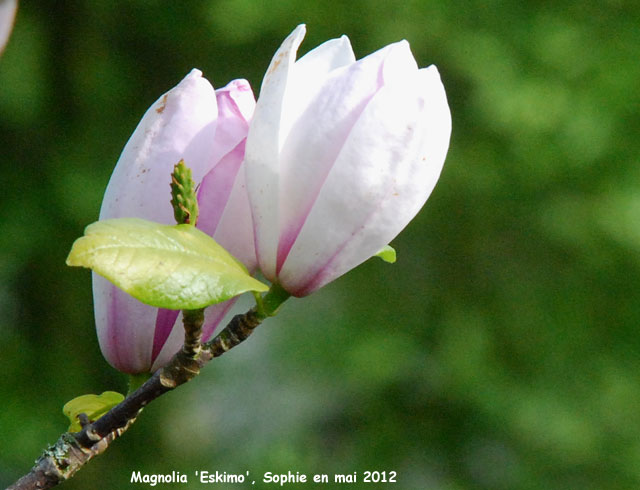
[245, 25, 305, 280]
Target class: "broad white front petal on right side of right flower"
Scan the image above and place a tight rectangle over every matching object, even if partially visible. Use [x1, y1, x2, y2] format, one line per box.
[280, 66, 451, 296]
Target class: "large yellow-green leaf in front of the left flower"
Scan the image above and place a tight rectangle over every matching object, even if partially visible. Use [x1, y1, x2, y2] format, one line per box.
[67, 218, 269, 310]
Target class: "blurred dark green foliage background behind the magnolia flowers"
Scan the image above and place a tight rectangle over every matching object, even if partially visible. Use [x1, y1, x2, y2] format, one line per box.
[0, 0, 640, 490]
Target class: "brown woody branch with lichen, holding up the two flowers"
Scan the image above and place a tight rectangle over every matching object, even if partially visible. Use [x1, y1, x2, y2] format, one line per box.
[7, 309, 265, 490]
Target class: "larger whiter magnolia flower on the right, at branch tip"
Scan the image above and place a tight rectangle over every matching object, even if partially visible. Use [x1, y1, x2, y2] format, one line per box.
[245, 25, 451, 296]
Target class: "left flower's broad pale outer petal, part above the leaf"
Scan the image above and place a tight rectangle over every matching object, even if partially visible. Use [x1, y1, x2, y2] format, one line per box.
[100, 70, 217, 224]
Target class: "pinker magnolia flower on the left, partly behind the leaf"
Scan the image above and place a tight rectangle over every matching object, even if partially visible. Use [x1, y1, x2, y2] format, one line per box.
[93, 70, 256, 374]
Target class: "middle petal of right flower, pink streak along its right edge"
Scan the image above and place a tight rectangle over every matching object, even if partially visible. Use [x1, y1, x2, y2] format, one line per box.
[276, 42, 418, 274]
